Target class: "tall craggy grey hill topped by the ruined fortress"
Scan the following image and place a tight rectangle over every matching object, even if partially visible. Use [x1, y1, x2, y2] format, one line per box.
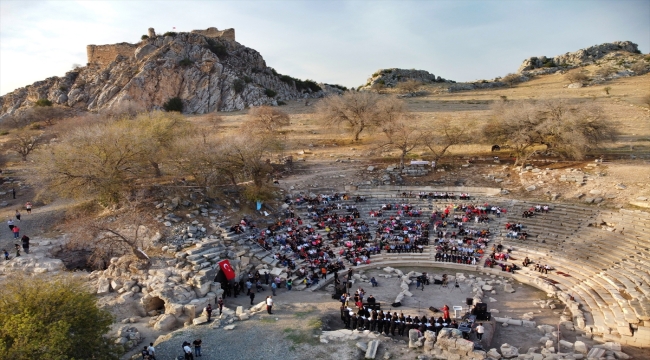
[0, 28, 323, 118]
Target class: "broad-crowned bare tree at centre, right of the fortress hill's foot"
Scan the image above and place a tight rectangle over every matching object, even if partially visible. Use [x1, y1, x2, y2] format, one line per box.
[317, 91, 395, 141]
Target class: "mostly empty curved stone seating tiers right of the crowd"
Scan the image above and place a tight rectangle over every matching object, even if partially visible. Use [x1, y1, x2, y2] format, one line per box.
[498, 202, 650, 347]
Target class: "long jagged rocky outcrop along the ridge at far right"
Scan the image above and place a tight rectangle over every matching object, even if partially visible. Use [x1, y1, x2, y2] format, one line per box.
[517, 41, 640, 73]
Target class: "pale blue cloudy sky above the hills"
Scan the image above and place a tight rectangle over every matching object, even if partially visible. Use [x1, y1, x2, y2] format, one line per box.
[0, 0, 650, 95]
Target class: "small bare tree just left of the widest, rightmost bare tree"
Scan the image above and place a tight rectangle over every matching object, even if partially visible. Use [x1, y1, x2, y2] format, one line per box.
[422, 117, 475, 163]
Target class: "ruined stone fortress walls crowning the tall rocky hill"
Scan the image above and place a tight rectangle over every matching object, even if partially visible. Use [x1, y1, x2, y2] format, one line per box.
[86, 27, 235, 67]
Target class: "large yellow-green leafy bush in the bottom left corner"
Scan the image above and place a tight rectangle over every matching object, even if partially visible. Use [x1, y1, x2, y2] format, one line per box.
[0, 276, 120, 359]
